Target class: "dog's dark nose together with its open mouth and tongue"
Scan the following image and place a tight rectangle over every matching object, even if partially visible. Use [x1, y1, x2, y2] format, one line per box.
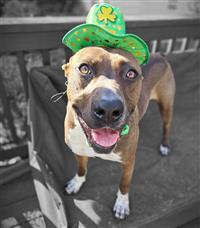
[75, 88, 124, 154]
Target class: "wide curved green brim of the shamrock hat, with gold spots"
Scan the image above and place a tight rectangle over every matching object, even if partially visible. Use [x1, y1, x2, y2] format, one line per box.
[62, 24, 149, 64]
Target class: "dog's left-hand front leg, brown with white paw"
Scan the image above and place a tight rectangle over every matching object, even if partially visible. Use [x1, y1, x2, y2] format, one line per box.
[65, 155, 88, 194]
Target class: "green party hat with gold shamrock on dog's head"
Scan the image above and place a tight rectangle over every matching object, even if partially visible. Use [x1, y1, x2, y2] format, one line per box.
[62, 3, 149, 64]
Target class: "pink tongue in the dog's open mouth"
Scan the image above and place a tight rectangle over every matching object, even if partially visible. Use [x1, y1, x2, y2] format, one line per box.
[91, 128, 119, 147]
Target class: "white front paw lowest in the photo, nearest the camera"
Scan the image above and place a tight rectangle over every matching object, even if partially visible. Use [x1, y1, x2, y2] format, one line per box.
[113, 190, 130, 219]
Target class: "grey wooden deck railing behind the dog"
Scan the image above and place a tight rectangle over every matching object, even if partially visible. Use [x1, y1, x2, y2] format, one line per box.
[0, 17, 200, 160]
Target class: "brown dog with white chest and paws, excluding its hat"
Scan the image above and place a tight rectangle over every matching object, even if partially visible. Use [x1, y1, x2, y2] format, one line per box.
[62, 47, 175, 219]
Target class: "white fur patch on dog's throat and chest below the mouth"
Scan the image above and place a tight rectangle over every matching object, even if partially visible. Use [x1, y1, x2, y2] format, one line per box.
[65, 120, 121, 162]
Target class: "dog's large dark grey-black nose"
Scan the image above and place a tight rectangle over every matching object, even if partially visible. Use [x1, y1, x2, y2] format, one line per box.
[92, 88, 124, 124]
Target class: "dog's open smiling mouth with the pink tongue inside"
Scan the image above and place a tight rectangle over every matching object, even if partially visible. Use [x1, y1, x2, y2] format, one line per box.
[78, 116, 120, 154]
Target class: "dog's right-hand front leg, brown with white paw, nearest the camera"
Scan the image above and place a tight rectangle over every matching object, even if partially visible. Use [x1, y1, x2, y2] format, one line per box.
[113, 159, 135, 219]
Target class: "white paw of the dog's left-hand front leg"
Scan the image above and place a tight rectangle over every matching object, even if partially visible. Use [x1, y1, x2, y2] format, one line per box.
[65, 174, 86, 194]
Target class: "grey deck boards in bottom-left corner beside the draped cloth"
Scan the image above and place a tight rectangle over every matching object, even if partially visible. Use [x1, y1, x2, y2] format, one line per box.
[0, 172, 44, 228]
